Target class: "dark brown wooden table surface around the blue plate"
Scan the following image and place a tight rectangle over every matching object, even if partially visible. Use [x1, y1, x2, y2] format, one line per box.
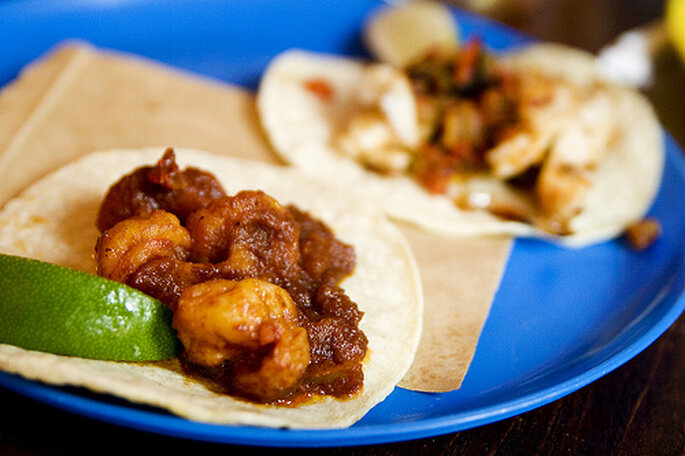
[0, 0, 685, 456]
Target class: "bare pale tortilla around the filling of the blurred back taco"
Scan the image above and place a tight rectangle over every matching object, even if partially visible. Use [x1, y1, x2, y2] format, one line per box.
[257, 44, 664, 246]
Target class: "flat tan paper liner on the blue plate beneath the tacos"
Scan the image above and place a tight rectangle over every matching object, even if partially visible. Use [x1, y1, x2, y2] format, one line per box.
[0, 43, 512, 392]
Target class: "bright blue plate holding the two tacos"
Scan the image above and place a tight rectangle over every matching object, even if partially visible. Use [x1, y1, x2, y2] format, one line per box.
[0, 0, 685, 447]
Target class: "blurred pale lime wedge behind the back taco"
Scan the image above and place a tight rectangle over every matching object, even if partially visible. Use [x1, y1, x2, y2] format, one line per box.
[364, 1, 459, 68]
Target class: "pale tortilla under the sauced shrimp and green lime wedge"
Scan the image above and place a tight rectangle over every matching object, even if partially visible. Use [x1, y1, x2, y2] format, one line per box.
[0, 148, 422, 428]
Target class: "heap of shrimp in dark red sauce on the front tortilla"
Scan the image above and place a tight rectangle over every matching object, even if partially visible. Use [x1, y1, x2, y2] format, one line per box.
[95, 149, 367, 404]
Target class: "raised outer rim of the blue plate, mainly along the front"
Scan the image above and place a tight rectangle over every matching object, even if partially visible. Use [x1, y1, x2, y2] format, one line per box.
[0, 0, 685, 447]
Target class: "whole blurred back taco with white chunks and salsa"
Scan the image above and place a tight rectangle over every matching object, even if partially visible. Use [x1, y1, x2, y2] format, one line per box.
[258, 39, 664, 246]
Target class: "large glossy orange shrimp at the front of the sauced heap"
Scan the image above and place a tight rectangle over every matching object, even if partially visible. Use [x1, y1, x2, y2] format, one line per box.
[173, 279, 309, 401]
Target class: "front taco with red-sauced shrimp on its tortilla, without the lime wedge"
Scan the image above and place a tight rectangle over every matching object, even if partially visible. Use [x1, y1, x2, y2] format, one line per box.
[0, 148, 422, 428]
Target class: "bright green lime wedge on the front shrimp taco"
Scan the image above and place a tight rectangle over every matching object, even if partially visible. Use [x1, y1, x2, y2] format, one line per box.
[0, 254, 178, 361]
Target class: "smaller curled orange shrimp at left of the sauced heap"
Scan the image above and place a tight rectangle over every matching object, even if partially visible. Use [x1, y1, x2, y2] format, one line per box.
[95, 210, 191, 283]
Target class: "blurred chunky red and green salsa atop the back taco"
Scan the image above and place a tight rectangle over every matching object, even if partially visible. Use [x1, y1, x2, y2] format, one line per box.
[405, 39, 519, 193]
